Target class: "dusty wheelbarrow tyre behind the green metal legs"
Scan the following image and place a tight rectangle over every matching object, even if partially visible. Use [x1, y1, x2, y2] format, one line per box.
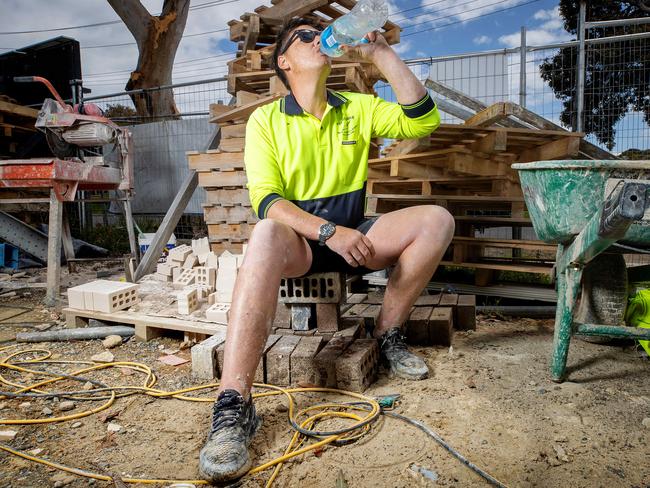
[575, 254, 627, 344]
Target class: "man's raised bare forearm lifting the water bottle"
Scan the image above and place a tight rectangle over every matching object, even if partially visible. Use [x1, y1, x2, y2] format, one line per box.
[373, 46, 427, 105]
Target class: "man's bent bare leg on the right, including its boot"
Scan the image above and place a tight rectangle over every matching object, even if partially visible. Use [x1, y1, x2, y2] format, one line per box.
[366, 205, 454, 380]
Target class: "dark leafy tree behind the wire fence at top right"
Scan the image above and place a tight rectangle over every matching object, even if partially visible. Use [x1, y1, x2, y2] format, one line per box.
[540, 0, 650, 150]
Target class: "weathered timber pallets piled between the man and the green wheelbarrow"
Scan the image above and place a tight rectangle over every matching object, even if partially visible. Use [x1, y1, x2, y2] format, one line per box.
[367, 80, 615, 285]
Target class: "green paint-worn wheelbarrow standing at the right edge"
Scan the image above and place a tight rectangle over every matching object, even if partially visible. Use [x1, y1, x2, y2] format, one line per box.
[512, 160, 650, 382]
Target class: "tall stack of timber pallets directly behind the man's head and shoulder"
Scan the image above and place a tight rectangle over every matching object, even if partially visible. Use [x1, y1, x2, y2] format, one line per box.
[188, 0, 400, 253]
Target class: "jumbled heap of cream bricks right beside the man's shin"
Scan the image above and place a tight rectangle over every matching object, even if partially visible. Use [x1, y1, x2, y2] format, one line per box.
[153, 237, 245, 325]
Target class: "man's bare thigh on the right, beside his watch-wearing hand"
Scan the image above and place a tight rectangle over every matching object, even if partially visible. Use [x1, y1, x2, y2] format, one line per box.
[366, 205, 444, 269]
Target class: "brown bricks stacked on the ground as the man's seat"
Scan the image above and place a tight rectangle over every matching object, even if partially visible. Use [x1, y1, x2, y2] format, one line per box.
[193, 273, 379, 391]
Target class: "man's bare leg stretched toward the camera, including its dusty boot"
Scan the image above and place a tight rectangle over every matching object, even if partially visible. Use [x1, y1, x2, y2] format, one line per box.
[199, 219, 312, 482]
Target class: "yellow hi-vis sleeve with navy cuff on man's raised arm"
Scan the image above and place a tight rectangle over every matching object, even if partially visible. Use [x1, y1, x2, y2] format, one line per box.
[372, 92, 440, 139]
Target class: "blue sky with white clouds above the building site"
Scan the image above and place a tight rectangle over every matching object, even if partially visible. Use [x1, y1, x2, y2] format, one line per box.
[0, 0, 569, 95]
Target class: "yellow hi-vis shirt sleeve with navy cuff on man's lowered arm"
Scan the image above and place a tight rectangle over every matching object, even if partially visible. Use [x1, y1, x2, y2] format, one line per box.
[244, 110, 284, 219]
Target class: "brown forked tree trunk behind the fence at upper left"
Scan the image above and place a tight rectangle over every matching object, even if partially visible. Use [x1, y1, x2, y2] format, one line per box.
[108, 0, 190, 120]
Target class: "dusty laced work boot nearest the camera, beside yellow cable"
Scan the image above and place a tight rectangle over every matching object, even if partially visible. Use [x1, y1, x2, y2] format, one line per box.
[199, 390, 262, 482]
